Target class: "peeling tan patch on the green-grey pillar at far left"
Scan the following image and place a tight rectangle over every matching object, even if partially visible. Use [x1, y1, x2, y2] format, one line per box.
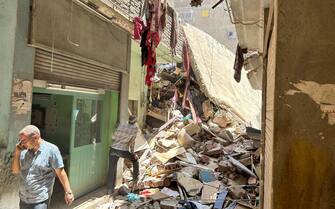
[12, 79, 33, 115]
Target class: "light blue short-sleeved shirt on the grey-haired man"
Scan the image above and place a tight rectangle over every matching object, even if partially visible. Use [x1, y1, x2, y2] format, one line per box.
[19, 141, 64, 204]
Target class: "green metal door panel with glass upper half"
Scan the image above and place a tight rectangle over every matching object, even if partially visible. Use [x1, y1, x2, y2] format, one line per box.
[69, 95, 106, 197]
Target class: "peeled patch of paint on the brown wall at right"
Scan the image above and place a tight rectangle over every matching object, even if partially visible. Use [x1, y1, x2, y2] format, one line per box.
[286, 81, 335, 125]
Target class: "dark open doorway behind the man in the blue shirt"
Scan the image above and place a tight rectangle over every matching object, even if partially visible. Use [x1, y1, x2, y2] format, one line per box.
[31, 93, 73, 205]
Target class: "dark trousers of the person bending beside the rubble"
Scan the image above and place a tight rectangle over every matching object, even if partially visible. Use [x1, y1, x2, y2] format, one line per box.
[107, 148, 139, 193]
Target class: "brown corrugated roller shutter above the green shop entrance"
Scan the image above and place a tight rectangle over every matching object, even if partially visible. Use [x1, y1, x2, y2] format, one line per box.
[34, 49, 121, 91]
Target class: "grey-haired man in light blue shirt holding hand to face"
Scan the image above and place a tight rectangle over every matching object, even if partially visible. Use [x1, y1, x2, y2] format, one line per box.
[12, 125, 74, 209]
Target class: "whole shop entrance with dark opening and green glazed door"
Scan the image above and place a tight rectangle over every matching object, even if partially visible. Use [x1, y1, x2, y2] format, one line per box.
[31, 88, 108, 204]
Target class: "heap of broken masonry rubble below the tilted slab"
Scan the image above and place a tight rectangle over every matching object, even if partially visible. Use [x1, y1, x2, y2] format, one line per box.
[102, 64, 261, 209]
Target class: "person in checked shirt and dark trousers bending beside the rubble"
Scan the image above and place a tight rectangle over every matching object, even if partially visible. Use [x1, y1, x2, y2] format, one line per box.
[107, 115, 139, 195]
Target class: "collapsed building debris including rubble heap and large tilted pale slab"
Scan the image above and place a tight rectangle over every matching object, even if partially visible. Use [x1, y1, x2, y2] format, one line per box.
[98, 25, 261, 209]
